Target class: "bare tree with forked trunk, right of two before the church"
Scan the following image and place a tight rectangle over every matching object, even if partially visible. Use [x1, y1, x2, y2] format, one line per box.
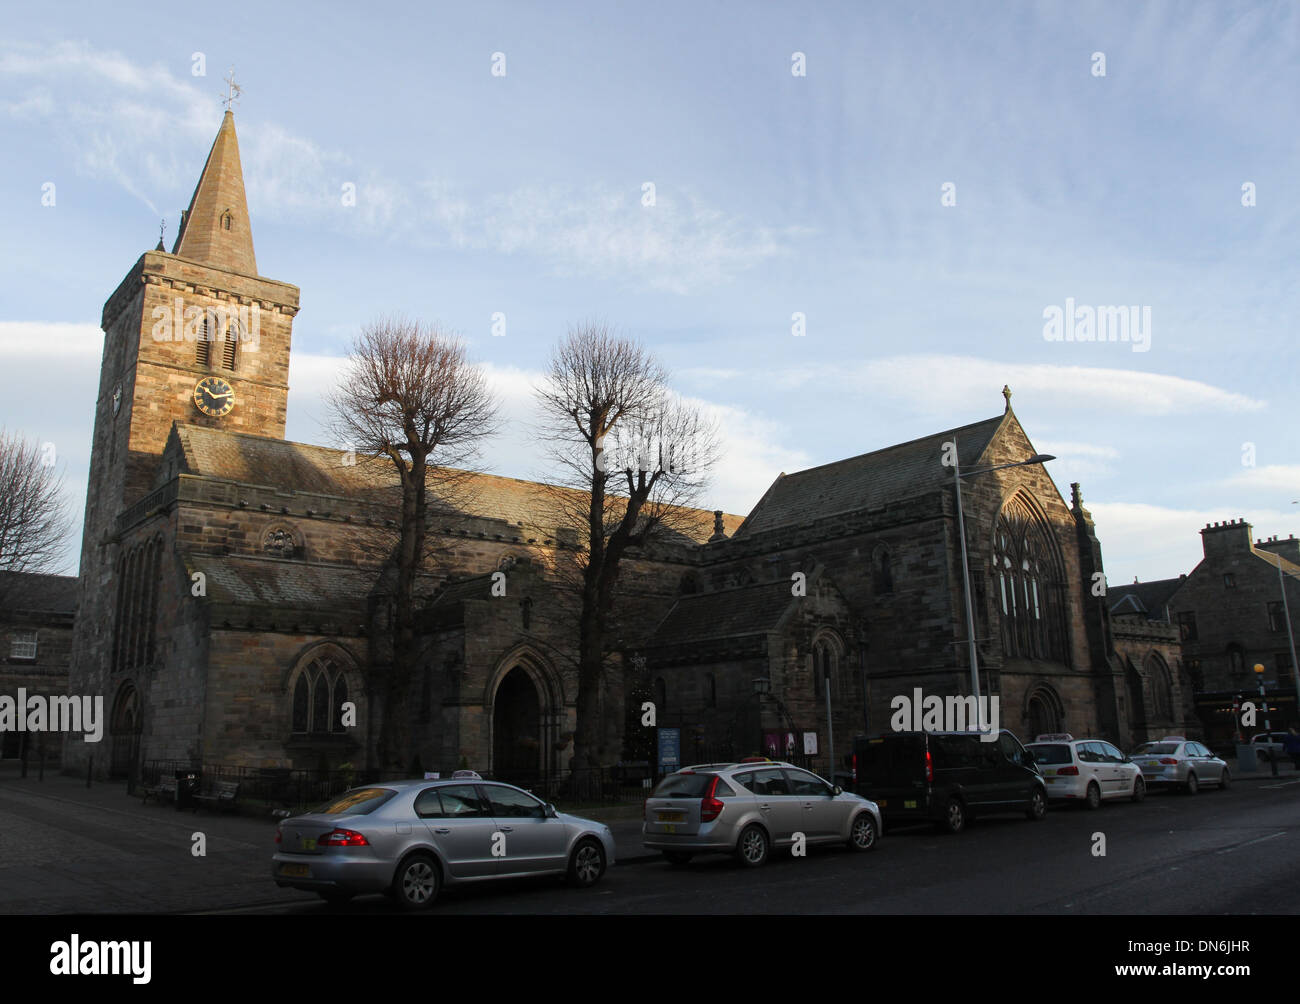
[537, 324, 718, 767]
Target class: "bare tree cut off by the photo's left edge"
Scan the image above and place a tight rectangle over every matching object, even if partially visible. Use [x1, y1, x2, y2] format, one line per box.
[0, 429, 72, 585]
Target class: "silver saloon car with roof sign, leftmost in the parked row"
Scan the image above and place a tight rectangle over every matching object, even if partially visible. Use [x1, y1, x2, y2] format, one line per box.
[272, 778, 614, 910]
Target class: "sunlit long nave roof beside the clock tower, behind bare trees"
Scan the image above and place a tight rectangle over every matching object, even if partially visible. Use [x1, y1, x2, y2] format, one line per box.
[176, 424, 744, 544]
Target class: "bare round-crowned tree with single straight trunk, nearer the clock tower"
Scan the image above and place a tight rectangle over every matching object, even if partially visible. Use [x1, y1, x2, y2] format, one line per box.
[329, 317, 497, 770]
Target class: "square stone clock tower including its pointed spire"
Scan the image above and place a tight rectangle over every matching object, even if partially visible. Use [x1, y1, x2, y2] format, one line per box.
[72, 111, 298, 780]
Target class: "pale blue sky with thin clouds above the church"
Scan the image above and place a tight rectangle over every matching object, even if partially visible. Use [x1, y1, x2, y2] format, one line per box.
[0, 3, 1300, 583]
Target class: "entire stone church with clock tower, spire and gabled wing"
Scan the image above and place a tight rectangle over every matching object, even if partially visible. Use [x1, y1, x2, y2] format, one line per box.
[65, 112, 1130, 782]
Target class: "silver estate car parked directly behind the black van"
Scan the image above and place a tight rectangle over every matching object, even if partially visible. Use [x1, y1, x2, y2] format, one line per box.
[641, 761, 880, 867]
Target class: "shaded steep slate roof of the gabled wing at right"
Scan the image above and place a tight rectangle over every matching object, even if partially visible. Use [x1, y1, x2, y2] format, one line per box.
[737, 412, 1009, 537]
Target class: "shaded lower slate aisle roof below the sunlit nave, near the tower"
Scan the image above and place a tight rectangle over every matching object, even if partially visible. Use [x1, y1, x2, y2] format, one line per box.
[185, 554, 376, 611]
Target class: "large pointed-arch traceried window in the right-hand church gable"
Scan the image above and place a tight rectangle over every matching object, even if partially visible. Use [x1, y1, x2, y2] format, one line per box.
[991, 497, 1069, 663]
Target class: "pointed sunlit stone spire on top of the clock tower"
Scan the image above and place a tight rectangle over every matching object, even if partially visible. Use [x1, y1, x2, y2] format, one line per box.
[172, 109, 257, 276]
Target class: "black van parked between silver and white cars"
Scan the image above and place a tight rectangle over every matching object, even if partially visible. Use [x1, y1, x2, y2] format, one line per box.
[853, 728, 1048, 834]
